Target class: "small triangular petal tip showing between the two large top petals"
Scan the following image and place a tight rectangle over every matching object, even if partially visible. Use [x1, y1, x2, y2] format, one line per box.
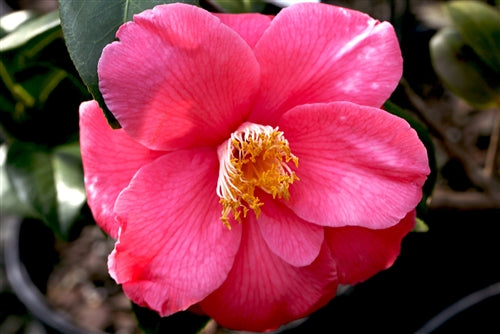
[214, 13, 273, 48]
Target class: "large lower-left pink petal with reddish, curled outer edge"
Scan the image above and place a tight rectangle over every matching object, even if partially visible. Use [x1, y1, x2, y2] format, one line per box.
[109, 149, 241, 316]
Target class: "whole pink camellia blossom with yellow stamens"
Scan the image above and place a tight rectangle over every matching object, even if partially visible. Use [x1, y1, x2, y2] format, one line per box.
[80, 3, 429, 331]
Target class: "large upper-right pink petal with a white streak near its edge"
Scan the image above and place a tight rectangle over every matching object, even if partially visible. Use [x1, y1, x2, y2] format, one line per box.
[250, 3, 403, 125]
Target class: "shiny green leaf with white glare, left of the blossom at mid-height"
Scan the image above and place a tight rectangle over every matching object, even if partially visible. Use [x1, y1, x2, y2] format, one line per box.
[2, 141, 86, 238]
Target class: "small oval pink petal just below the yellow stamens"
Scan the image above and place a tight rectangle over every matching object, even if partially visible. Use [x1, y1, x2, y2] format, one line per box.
[257, 192, 324, 267]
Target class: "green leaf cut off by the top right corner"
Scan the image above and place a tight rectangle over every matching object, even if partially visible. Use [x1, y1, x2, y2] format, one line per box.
[447, 1, 500, 73]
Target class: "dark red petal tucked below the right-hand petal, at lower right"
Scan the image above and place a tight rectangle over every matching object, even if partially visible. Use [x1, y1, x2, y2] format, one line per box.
[325, 211, 415, 284]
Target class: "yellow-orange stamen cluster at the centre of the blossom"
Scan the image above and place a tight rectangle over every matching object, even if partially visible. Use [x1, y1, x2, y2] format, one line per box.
[217, 123, 299, 229]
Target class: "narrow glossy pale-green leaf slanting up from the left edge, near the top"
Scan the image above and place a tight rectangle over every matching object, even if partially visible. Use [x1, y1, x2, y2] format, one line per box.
[0, 12, 59, 52]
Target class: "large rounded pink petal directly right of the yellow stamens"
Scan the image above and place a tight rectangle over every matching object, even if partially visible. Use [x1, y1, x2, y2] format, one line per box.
[279, 102, 429, 229]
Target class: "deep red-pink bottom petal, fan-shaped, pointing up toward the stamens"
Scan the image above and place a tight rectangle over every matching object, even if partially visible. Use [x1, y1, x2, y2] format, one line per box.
[200, 216, 337, 331]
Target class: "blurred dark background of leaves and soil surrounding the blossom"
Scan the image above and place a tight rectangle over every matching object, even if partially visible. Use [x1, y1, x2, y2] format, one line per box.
[0, 0, 500, 334]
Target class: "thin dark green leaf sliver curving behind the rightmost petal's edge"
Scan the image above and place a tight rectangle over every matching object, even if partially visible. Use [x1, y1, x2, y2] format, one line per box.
[384, 101, 438, 213]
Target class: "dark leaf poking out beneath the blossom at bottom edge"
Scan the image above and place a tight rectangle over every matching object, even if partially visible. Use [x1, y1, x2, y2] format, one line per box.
[132, 304, 210, 334]
